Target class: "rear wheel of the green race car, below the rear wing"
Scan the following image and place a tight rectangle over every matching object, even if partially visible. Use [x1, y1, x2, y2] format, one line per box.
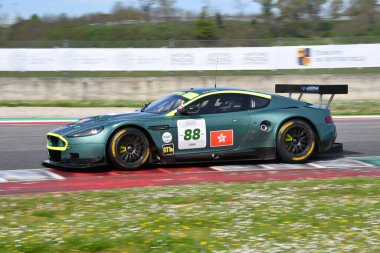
[276, 119, 316, 163]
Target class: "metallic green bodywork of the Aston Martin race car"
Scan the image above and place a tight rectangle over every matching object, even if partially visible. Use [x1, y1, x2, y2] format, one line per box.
[46, 88, 336, 166]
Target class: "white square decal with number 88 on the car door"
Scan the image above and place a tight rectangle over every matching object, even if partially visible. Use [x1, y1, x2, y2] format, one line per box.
[177, 119, 206, 149]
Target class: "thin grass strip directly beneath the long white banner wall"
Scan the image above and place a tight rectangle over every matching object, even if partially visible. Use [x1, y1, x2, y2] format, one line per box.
[0, 68, 380, 78]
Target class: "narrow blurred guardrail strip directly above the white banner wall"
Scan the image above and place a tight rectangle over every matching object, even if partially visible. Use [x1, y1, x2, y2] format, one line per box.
[0, 36, 380, 48]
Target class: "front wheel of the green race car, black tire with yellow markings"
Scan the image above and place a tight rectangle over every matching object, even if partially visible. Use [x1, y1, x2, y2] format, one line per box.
[107, 127, 150, 170]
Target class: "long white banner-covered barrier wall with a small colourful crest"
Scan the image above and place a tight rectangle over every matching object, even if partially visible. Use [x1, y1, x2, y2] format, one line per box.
[0, 44, 380, 71]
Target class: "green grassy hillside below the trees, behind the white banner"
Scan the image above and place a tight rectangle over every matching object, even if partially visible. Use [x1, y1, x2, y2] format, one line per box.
[5, 16, 380, 48]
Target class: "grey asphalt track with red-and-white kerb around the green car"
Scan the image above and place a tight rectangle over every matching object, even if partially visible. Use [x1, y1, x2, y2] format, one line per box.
[0, 119, 380, 194]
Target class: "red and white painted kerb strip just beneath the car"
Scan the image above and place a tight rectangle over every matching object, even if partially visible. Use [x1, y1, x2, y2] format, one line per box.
[0, 158, 380, 184]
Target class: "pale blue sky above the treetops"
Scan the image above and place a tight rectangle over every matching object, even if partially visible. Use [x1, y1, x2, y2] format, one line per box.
[0, 0, 260, 21]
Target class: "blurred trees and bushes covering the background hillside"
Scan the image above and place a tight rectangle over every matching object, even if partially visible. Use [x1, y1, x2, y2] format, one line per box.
[1, 0, 380, 41]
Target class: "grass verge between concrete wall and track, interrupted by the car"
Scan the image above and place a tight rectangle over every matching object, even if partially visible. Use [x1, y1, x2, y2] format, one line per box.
[0, 100, 380, 115]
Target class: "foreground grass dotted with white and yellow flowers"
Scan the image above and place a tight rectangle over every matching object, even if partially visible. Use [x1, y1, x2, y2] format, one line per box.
[0, 178, 380, 253]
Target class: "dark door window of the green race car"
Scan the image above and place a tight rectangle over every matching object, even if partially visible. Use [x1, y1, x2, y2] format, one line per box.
[188, 93, 249, 114]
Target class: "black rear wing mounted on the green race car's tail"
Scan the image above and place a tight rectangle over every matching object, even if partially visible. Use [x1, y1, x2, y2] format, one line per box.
[276, 84, 348, 108]
